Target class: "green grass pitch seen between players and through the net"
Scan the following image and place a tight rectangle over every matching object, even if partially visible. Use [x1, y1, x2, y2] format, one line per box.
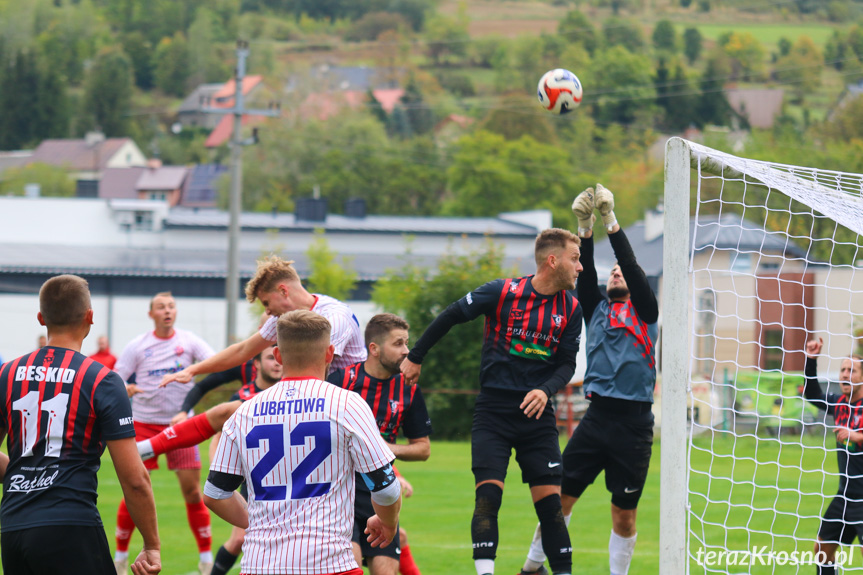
[8, 437, 844, 575]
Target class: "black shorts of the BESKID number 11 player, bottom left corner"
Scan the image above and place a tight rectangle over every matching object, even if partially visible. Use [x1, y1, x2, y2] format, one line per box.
[0, 525, 117, 575]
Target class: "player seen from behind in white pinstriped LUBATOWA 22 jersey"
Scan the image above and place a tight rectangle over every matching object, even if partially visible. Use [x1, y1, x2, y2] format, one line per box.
[204, 310, 401, 575]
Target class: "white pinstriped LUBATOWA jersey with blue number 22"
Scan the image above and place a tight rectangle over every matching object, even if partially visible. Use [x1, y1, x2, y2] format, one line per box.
[210, 378, 395, 574]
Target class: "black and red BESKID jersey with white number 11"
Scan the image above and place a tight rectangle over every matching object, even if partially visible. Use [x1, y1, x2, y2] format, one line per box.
[0, 346, 135, 532]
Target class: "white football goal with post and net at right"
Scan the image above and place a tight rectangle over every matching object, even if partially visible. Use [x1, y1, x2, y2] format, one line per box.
[660, 138, 863, 575]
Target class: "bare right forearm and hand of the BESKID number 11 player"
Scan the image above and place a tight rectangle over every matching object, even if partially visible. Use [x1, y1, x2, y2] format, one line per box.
[107, 437, 162, 575]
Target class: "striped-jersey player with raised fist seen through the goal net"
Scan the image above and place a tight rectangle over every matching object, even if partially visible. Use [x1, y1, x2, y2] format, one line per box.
[803, 338, 863, 575]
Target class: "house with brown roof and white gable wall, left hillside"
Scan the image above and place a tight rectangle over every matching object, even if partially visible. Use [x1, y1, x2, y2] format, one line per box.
[27, 132, 147, 180]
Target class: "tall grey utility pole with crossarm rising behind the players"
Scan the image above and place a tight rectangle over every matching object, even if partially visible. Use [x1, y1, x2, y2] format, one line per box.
[203, 40, 280, 346]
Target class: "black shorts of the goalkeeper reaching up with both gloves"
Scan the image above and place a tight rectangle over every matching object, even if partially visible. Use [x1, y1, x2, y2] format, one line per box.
[561, 404, 653, 509]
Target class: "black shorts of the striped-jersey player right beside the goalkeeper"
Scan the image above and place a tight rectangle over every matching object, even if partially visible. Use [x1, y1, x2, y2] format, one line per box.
[471, 392, 562, 487]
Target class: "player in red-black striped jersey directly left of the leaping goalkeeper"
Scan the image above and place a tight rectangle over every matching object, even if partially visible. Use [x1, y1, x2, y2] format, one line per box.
[401, 229, 582, 575]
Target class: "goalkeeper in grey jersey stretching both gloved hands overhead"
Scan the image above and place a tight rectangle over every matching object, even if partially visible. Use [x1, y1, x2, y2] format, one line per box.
[522, 184, 659, 575]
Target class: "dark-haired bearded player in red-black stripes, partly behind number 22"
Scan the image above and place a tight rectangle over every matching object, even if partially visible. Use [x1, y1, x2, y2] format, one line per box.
[327, 313, 432, 575]
